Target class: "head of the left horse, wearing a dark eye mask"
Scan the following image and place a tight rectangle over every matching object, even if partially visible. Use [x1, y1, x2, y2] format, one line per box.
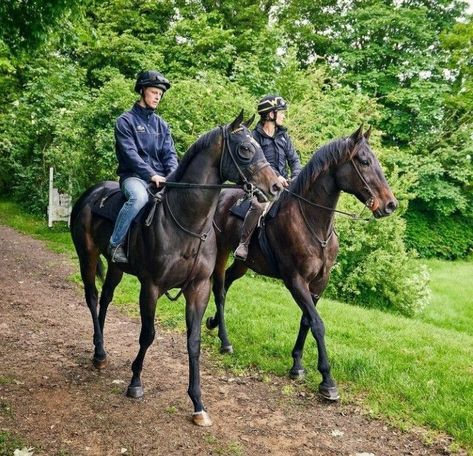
[220, 110, 282, 201]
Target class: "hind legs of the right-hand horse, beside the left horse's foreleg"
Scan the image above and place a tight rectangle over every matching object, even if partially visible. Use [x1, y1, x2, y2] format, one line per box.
[207, 255, 248, 353]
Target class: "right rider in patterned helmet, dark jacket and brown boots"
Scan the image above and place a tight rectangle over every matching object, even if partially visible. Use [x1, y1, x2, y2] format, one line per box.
[235, 95, 301, 261]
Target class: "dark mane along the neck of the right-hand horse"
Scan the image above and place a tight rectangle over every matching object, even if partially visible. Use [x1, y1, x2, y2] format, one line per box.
[289, 138, 353, 195]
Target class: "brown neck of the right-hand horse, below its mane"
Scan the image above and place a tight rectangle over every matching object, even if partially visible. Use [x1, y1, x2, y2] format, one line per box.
[295, 171, 340, 238]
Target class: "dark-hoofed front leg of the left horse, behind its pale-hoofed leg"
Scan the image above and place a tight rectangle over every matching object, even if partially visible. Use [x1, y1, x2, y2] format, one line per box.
[126, 281, 160, 399]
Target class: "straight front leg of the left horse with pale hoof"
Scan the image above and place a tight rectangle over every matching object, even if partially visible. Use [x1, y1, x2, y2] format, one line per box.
[184, 279, 212, 426]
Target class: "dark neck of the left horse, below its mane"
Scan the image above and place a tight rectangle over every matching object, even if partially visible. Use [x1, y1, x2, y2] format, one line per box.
[167, 142, 221, 231]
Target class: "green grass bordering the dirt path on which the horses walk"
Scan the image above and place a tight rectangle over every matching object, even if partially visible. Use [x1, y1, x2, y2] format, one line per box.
[0, 202, 473, 454]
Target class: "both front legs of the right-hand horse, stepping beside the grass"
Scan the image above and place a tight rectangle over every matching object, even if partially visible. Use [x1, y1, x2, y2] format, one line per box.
[288, 278, 340, 401]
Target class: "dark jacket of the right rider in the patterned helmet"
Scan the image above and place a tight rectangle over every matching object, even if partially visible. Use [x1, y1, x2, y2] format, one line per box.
[253, 122, 301, 179]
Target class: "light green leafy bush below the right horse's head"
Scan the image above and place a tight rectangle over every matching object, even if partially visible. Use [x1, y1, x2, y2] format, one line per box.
[327, 195, 430, 316]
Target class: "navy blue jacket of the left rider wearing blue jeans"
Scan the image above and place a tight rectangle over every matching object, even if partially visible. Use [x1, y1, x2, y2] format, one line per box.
[115, 103, 177, 182]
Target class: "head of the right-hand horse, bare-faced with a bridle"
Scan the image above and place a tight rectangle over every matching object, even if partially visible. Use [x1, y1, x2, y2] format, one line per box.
[336, 125, 398, 218]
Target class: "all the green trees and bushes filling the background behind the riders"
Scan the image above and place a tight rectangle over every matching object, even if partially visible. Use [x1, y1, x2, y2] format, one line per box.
[0, 0, 473, 314]
